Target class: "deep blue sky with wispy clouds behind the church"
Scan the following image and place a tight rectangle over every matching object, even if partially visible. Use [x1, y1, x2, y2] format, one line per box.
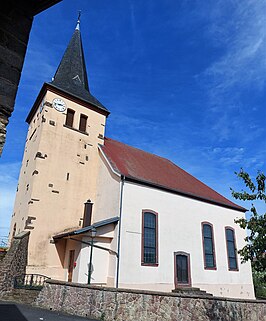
[0, 0, 266, 236]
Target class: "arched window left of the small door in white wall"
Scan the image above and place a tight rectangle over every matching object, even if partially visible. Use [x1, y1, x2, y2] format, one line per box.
[141, 210, 158, 266]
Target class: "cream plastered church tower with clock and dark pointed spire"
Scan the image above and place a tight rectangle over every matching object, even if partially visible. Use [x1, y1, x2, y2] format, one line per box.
[10, 20, 109, 279]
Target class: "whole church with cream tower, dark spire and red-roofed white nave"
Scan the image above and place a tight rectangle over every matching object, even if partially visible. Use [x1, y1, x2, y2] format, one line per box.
[10, 21, 254, 298]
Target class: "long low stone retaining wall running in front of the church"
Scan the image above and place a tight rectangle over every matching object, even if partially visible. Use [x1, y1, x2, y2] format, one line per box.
[36, 280, 266, 321]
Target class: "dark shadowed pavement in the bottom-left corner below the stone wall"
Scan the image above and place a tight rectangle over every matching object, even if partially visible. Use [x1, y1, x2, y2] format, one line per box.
[0, 301, 96, 321]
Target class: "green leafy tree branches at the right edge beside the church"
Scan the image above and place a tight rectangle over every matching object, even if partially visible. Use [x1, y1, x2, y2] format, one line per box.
[231, 169, 266, 272]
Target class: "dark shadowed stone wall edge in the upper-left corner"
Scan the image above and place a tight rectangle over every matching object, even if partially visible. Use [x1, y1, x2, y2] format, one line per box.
[0, 0, 33, 155]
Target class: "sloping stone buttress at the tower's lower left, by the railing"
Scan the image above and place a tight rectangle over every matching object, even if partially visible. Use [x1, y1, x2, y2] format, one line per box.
[0, 232, 30, 296]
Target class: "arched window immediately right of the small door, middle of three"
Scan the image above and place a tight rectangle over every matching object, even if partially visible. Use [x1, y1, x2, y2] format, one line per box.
[201, 222, 216, 270]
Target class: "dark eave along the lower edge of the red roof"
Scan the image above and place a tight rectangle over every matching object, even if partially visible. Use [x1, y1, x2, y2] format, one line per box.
[121, 174, 248, 213]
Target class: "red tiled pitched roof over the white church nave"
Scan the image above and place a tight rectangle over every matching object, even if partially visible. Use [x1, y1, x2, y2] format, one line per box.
[101, 138, 246, 212]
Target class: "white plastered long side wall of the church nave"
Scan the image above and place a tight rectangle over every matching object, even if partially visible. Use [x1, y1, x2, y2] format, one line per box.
[119, 182, 254, 298]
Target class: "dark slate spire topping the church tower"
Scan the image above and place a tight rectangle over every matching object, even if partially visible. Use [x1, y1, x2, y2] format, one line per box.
[50, 14, 108, 111]
